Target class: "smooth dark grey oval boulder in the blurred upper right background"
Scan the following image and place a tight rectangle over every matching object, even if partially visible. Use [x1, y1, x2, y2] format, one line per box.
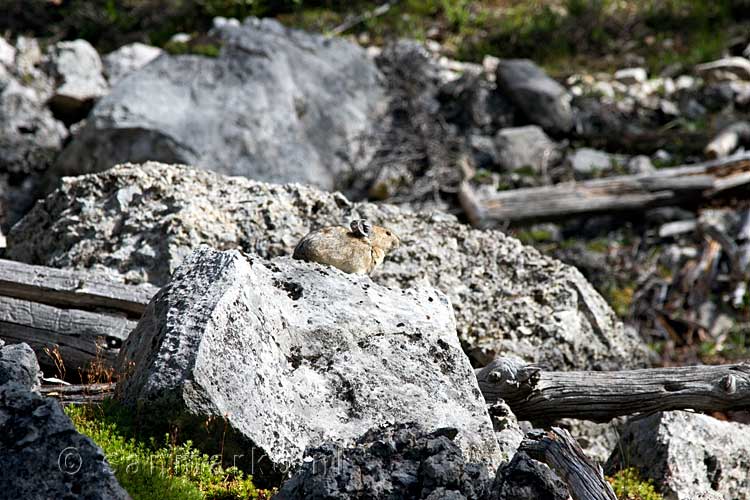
[496, 59, 573, 135]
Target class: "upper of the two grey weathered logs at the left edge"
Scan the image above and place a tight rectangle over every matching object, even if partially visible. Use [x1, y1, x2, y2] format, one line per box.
[0, 259, 158, 317]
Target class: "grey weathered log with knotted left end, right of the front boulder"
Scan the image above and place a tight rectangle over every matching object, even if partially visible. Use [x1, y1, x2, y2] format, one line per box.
[476, 358, 750, 422]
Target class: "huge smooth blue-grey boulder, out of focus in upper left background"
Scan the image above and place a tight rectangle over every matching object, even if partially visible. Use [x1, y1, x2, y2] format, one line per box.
[55, 18, 384, 188]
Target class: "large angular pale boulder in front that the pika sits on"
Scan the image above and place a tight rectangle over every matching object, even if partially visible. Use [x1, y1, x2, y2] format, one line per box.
[117, 246, 500, 480]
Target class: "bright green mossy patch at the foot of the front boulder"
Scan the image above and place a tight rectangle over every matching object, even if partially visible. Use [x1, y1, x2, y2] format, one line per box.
[65, 401, 266, 500]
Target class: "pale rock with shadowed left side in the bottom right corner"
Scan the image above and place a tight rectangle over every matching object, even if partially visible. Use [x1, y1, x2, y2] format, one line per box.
[607, 411, 750, 500]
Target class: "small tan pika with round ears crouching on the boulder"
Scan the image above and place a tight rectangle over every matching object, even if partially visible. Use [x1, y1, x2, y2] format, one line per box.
[292, 219, 400, 274]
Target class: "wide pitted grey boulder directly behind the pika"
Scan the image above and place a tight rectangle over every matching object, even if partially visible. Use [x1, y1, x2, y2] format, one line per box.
[6, 163, 647, 369]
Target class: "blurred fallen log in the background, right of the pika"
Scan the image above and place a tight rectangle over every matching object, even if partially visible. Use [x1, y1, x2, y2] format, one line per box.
[459, 150, 750, 228]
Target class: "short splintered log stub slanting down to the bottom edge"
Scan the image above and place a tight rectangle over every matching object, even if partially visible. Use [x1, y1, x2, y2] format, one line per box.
[519, 427, 617, 500]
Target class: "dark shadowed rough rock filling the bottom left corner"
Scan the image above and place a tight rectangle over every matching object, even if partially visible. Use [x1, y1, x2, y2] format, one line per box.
[0, 340, 130, 500]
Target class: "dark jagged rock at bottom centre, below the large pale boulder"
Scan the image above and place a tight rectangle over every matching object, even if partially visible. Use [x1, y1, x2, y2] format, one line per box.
[274, 425, 491, 500]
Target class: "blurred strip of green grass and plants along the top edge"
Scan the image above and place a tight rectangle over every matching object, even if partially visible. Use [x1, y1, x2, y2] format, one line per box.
[0, 0, 750, 73]
